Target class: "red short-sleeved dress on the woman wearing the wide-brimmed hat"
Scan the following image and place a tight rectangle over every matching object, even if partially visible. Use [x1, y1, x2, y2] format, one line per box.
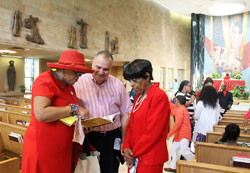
[22, 71, 78, 173]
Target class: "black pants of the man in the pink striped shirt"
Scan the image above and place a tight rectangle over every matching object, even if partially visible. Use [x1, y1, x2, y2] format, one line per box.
[88, 128, 121, 173]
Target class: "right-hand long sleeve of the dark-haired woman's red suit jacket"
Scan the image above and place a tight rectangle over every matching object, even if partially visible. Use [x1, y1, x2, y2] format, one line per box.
[132, 93, 170, 157]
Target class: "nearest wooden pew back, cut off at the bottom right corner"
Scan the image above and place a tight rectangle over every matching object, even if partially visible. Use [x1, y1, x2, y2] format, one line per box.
[176, 160, 249, 173]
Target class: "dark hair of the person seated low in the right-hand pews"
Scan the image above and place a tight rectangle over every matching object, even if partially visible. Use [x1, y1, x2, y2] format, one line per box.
[221, 123, 240, 142]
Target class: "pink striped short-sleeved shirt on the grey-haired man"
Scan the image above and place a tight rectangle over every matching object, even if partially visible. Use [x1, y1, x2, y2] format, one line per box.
[74, 74, 132, 131]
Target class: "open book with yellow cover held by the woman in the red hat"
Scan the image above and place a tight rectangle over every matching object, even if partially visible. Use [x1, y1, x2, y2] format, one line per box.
[60, 112, 120, 128]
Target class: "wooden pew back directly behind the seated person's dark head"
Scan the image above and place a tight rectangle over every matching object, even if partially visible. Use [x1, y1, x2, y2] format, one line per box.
[206, 132, 250, 143]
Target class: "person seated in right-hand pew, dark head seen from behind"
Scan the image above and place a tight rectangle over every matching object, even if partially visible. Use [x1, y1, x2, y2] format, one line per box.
[215, 123, 240, 145]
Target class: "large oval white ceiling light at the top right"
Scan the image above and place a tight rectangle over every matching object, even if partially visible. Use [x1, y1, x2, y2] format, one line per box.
[209, 3, 246, 16]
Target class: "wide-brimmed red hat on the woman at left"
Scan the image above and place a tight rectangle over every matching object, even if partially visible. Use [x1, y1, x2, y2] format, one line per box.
[47, 49, 93, 73]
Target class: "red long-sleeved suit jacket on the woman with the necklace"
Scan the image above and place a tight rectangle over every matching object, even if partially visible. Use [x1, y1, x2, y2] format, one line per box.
[123, 85, 170, 165]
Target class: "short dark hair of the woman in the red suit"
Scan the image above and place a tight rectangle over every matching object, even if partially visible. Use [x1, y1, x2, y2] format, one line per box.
[123, 59, 154, 80]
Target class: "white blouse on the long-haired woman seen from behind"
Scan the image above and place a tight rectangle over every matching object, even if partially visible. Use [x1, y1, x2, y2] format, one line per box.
[194, 101, 221, 135]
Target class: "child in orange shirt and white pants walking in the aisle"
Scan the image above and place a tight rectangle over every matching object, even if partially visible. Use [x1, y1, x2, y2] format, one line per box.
[164, 96, 194, 171]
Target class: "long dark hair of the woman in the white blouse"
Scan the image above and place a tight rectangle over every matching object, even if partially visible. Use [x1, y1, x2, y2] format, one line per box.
[199, 86, 219, 108]
